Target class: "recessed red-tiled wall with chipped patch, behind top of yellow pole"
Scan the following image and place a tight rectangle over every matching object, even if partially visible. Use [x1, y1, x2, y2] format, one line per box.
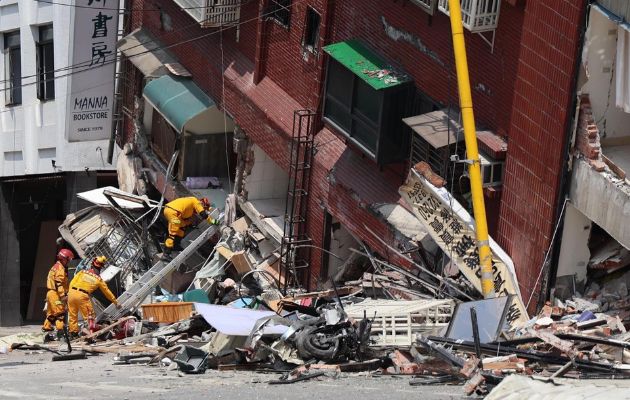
[333, 0, 524, 135]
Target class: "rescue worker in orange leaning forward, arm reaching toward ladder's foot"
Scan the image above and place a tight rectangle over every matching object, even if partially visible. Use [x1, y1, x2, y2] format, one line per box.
[68, 256, 120, 339]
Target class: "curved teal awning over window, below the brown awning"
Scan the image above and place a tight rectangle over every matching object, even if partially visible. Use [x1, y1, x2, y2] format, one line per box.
[144, 75, 215, 132]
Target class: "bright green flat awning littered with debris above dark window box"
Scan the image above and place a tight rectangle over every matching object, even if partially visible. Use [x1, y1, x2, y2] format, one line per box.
[324, 39, 411, 90]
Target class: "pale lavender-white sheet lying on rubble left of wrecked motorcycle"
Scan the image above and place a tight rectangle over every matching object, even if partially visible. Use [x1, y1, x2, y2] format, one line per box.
[195, 303, 289, 336]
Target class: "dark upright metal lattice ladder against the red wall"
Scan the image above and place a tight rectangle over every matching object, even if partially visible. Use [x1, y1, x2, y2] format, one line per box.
[280, 110, 315, 294]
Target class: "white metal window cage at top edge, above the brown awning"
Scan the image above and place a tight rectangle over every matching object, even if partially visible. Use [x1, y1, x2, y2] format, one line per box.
[174, 0, 241, 28]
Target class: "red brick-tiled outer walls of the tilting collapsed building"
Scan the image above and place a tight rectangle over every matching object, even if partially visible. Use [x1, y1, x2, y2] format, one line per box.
[123, 0, 583, 296]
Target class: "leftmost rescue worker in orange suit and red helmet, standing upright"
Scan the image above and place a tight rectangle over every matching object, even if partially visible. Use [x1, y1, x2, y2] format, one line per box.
[42, 249, 74, 334]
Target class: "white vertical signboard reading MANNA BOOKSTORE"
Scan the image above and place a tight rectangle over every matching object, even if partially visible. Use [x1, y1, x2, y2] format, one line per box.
[67, 0, 118, 142]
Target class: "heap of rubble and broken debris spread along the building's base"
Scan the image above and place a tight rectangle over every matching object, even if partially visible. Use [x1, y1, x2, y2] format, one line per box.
[8, 176, 630, 398]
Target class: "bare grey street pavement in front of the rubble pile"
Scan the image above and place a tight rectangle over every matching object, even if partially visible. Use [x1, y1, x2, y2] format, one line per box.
[0, 350, 469, 400]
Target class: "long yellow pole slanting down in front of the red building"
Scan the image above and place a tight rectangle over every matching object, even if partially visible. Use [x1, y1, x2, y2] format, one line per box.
[448, 0, 495, 299]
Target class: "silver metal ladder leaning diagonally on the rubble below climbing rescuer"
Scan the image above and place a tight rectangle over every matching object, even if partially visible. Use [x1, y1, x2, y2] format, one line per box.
[96, 225, 219, 322]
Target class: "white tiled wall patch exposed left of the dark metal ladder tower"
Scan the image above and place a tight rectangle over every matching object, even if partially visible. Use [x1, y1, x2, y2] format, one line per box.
[245, 145, 289, 200]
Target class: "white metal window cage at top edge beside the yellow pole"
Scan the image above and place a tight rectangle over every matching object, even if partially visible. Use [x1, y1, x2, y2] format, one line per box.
[438, 0, 501, 33]
